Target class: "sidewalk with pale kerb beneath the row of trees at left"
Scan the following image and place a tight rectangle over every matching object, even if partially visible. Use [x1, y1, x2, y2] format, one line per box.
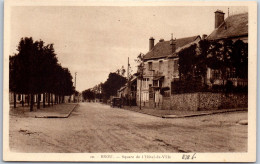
[10, 103, 78, 118]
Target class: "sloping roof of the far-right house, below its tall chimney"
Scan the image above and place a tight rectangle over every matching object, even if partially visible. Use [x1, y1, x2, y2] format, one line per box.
[207, 13, 248, 40]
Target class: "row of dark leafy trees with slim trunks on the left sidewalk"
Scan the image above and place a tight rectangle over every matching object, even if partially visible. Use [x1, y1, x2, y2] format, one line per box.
[9, 37, 74, 111]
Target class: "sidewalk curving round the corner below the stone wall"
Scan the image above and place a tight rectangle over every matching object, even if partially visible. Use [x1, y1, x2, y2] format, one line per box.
[123, 106, 247, 118]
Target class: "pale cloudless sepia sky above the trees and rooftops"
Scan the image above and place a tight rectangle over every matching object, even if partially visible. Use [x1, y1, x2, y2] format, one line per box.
[10, 6, 247, 91]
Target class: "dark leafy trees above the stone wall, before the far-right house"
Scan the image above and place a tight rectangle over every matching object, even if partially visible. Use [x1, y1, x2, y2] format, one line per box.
[176, 39, 248, 91]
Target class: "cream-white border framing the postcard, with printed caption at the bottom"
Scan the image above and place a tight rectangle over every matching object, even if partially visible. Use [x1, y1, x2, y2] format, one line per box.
[3, 0, 257, 162]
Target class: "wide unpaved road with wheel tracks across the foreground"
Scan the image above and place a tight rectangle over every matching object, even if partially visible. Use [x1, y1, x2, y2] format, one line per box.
[9, 103, 248, 153]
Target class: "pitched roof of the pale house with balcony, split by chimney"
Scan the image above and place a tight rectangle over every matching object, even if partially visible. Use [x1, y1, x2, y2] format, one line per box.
[144, 35, 200, 60]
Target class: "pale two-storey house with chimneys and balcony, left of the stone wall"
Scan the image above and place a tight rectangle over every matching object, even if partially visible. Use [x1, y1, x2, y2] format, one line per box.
[137, 35, 201, 108]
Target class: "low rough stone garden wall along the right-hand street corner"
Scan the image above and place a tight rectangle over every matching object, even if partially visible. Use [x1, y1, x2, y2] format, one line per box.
[161, 92, 248, 111]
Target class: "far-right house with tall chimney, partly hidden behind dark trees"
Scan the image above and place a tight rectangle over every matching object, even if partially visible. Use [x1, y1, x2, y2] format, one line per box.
[206, 10, 248, 86]
